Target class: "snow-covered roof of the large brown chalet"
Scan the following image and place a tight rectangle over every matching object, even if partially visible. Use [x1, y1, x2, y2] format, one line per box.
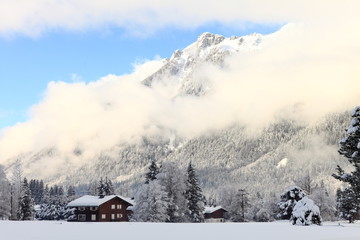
[68, 195, 134, 207]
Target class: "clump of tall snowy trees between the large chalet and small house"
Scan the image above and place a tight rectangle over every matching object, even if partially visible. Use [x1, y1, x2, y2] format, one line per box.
[131, 160, 206, 222]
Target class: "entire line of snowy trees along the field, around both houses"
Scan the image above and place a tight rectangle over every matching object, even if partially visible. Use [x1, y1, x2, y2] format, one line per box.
[0, 160, 351, 223]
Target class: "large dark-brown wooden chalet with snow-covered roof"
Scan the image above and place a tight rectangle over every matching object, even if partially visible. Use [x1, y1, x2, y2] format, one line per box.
[68, 195, 134, 222]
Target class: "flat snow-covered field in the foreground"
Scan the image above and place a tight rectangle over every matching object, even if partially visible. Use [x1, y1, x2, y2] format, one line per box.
[0, 221, 360, 240]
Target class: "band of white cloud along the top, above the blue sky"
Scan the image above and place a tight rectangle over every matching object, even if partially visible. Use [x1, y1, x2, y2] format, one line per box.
[0, 0, 359, 36]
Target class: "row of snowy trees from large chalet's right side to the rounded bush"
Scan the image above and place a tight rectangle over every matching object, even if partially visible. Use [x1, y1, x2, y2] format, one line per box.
[131, 160, 336, 225]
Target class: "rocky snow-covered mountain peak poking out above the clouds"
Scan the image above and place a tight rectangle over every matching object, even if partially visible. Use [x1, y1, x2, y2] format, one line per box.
[143, 32, 267, 97]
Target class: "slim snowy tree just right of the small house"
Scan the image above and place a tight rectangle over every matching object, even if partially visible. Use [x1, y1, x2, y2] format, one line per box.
[230, 189, 250, 222]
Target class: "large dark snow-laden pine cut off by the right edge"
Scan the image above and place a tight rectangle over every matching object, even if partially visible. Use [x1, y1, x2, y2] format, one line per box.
[332, 106, 360, 222]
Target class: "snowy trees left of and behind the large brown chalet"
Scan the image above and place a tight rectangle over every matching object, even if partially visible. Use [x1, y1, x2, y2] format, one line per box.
[0, 161, 114, 220]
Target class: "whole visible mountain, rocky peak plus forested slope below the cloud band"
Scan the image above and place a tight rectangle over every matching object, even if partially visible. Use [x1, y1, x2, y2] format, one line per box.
[2, 33, 349, 198]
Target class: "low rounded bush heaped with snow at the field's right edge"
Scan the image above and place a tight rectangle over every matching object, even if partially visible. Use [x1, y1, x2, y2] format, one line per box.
[291, 197, 322, 226]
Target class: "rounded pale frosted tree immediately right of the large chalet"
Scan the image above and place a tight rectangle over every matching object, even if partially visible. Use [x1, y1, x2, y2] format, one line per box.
[131, 180, 169, 222]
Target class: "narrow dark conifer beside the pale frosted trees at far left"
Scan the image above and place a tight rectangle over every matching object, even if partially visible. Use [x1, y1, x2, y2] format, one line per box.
[18, 178, 34, 220]
